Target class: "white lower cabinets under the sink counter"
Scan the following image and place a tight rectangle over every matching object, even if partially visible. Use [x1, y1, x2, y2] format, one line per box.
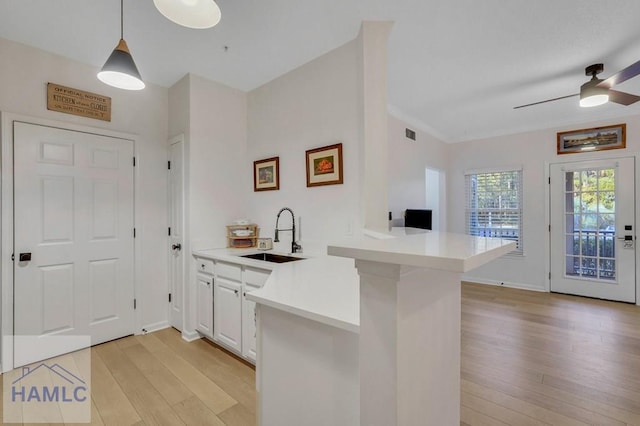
[195, 257, 271, 363]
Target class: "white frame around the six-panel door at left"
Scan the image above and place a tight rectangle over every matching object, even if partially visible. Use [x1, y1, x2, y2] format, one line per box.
[0, 111, 142, 372]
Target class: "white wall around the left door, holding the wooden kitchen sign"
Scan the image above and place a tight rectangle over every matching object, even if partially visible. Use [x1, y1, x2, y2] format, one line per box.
[0, 39, 168, 329]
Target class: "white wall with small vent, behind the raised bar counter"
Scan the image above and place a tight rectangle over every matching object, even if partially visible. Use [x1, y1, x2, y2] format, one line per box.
[388, 114, 449, 230]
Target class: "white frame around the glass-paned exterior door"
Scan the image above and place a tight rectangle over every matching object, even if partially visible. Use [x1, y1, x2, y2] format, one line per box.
[544, 152, 640, 306]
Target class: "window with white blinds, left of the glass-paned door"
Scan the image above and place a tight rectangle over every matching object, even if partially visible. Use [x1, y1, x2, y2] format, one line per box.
[465, 170, 523, 255]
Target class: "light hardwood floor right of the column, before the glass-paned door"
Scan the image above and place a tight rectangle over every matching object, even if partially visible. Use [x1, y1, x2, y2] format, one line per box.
[461, 283, 640, 426]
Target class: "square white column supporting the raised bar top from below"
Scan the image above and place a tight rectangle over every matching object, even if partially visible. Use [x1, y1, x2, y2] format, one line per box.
[356, 260, 461, 426]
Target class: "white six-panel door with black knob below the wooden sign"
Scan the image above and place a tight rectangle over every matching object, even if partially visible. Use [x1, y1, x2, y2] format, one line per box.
[14, 122, 134, 366]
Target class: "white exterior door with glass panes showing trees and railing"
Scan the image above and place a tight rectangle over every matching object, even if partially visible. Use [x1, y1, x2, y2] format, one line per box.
[549, 158, 636, 302]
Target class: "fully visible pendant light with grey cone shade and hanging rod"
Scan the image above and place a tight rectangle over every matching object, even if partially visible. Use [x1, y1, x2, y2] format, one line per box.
[98, 0, 145, 90]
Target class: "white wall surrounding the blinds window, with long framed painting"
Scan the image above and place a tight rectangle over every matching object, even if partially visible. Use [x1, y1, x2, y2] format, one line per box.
[447, 116, 640, 290]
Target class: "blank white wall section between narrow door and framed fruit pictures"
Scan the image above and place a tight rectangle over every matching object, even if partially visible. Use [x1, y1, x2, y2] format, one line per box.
[188, 74, 251, 250]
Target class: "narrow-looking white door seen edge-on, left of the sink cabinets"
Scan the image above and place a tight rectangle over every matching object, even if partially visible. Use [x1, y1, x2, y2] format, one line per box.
[169, 138, 184, 330]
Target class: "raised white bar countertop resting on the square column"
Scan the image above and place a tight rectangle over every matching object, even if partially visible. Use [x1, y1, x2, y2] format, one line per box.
[327, 228, 516, 272]
